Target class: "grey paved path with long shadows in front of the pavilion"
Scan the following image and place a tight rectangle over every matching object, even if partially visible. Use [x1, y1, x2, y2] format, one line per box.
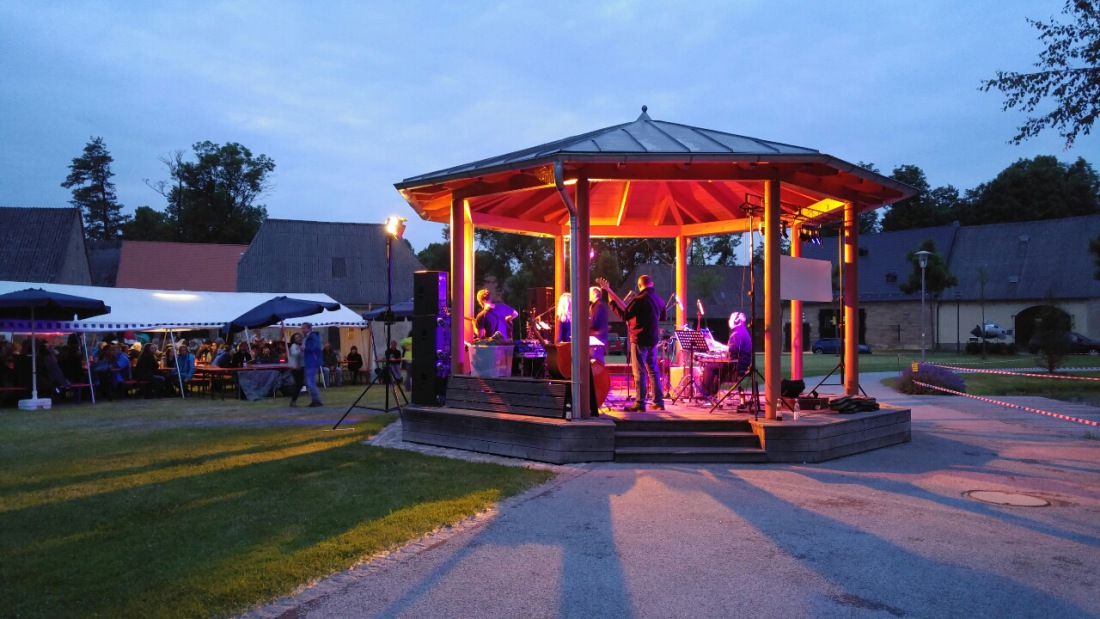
[249, 374, 1100, 619]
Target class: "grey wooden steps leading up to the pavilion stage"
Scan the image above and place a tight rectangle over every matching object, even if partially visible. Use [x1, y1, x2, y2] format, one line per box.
[615, 419, 768, 462]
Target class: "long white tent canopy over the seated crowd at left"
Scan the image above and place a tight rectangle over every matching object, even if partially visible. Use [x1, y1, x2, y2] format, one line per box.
[0, 281, 367, 332]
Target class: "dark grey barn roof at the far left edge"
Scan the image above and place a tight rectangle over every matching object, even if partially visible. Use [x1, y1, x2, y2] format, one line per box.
[0, 207, 91, 285]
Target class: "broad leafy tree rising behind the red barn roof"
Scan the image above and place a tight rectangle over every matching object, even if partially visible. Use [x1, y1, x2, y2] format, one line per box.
[146, 142, 275, 243]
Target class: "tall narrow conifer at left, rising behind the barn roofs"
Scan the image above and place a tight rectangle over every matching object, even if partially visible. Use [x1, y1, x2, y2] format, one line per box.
[62, 137, 129, 240]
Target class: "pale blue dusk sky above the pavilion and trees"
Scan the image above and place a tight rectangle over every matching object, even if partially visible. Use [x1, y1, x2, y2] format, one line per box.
[0, 0, 1100, 258]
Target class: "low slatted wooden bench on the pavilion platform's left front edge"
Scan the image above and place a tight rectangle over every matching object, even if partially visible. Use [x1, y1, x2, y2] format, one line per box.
[447, 375, 570, 418]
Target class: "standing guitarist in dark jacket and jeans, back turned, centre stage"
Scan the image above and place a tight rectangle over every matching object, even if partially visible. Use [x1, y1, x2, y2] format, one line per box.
[596, 275, 675, 412]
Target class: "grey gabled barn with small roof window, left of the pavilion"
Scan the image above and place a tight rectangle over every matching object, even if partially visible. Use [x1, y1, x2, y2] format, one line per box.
[237, 219, 424, 307]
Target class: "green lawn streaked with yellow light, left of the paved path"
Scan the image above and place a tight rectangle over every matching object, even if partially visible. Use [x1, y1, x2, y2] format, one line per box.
[0, 387, 551, 618]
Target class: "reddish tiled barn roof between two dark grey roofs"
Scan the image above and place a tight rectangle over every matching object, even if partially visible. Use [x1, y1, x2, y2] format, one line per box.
[114, 241, 249, 292]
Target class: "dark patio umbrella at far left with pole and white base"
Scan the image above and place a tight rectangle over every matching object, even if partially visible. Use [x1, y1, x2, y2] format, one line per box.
[0, 288, 111, 408]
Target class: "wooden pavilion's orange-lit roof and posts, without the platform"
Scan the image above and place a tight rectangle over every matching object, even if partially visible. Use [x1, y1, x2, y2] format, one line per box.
[396, 107, 915, 461]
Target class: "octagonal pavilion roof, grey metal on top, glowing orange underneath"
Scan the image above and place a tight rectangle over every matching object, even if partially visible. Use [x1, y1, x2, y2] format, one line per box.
[396, 108, 915, 236]
